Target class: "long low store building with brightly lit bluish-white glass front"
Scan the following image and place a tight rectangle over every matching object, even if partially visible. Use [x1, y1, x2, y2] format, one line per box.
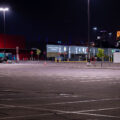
[47, 45, 120, 61]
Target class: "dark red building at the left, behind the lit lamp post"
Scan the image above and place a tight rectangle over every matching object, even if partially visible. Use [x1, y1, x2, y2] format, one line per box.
[0, 34, 30, 60]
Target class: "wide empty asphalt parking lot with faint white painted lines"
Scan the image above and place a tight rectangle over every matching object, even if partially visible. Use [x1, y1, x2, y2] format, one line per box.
[0, 62, 120, 120]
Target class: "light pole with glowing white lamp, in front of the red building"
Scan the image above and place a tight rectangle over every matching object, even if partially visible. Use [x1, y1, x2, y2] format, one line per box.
[0, 7, 9, 57]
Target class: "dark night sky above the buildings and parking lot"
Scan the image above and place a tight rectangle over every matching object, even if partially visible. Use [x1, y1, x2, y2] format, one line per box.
[0, 0, 120, 46]
